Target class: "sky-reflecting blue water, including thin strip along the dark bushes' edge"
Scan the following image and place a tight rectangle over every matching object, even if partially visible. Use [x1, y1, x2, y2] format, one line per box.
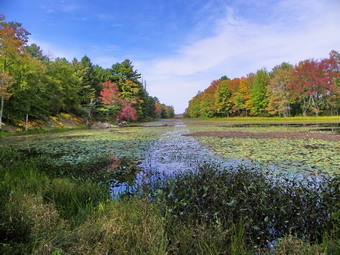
[111, 122, 322, 199]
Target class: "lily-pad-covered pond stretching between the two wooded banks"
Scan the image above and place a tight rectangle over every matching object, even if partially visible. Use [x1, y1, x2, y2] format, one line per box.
[0, 119, 340, 188]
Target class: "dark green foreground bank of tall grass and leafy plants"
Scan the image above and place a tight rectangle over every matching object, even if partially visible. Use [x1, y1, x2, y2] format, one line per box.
[0, 149, 340, 254]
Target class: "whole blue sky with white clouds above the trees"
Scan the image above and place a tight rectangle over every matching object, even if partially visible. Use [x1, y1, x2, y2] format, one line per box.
[0, 0, 340, 113]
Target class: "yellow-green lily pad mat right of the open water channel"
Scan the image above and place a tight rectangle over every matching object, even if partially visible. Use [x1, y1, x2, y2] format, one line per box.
[183, 117, 340, 175]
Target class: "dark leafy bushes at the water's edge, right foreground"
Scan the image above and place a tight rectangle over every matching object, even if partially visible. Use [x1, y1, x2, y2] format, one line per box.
[149, 165, 340, 248]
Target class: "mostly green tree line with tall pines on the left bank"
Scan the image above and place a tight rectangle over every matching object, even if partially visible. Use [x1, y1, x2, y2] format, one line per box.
[0, 15, 174, 128]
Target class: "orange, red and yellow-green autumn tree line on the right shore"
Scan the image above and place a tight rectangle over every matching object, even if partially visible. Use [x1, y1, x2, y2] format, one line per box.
[185, 50, 340, 118]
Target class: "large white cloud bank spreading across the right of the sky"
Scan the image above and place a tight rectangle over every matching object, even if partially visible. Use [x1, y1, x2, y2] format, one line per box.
[137, 0, 340, 113]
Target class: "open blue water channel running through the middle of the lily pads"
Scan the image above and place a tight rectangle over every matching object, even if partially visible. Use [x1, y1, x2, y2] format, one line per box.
[111, 121, 247, 198]
